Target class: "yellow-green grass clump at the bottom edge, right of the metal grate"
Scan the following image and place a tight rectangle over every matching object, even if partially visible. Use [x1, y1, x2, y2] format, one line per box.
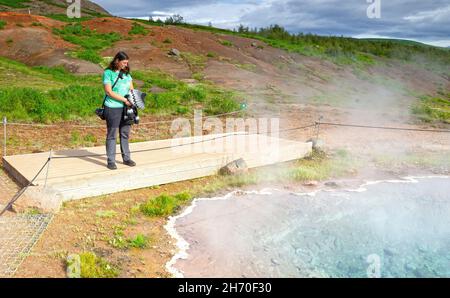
[66, 252, 119, 278]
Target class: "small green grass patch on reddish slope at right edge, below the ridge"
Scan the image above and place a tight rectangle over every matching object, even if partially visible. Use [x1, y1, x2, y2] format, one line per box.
[412, 93, 450, 124]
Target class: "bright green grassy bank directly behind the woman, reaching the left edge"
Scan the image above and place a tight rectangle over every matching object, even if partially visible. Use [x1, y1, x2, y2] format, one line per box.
[0, 58, 240, 123]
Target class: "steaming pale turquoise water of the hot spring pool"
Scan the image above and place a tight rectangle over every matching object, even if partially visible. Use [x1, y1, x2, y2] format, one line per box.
[175, 177, 450, 277]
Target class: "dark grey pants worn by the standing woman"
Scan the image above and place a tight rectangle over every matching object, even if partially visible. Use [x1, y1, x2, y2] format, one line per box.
[105, 107, 131, 163]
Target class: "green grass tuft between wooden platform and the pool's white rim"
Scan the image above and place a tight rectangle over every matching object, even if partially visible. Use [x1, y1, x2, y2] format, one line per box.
[140, 192, 192, 217]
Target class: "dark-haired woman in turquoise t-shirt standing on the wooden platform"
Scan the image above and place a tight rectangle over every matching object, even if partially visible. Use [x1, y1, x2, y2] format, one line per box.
[103, 52, 136, 170]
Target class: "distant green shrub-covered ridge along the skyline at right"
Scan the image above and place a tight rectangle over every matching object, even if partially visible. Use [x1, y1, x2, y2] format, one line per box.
[136, 19, 450, 71]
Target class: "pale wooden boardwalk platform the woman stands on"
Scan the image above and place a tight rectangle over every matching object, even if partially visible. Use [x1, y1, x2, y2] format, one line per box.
[3, 133, 312, 201]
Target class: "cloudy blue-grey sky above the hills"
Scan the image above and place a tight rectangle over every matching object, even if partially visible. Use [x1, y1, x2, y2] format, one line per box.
[92, 0, 450, 47]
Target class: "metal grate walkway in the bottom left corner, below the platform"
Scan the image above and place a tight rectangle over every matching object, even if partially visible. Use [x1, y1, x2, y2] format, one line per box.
[0, 214, 53, 277]
